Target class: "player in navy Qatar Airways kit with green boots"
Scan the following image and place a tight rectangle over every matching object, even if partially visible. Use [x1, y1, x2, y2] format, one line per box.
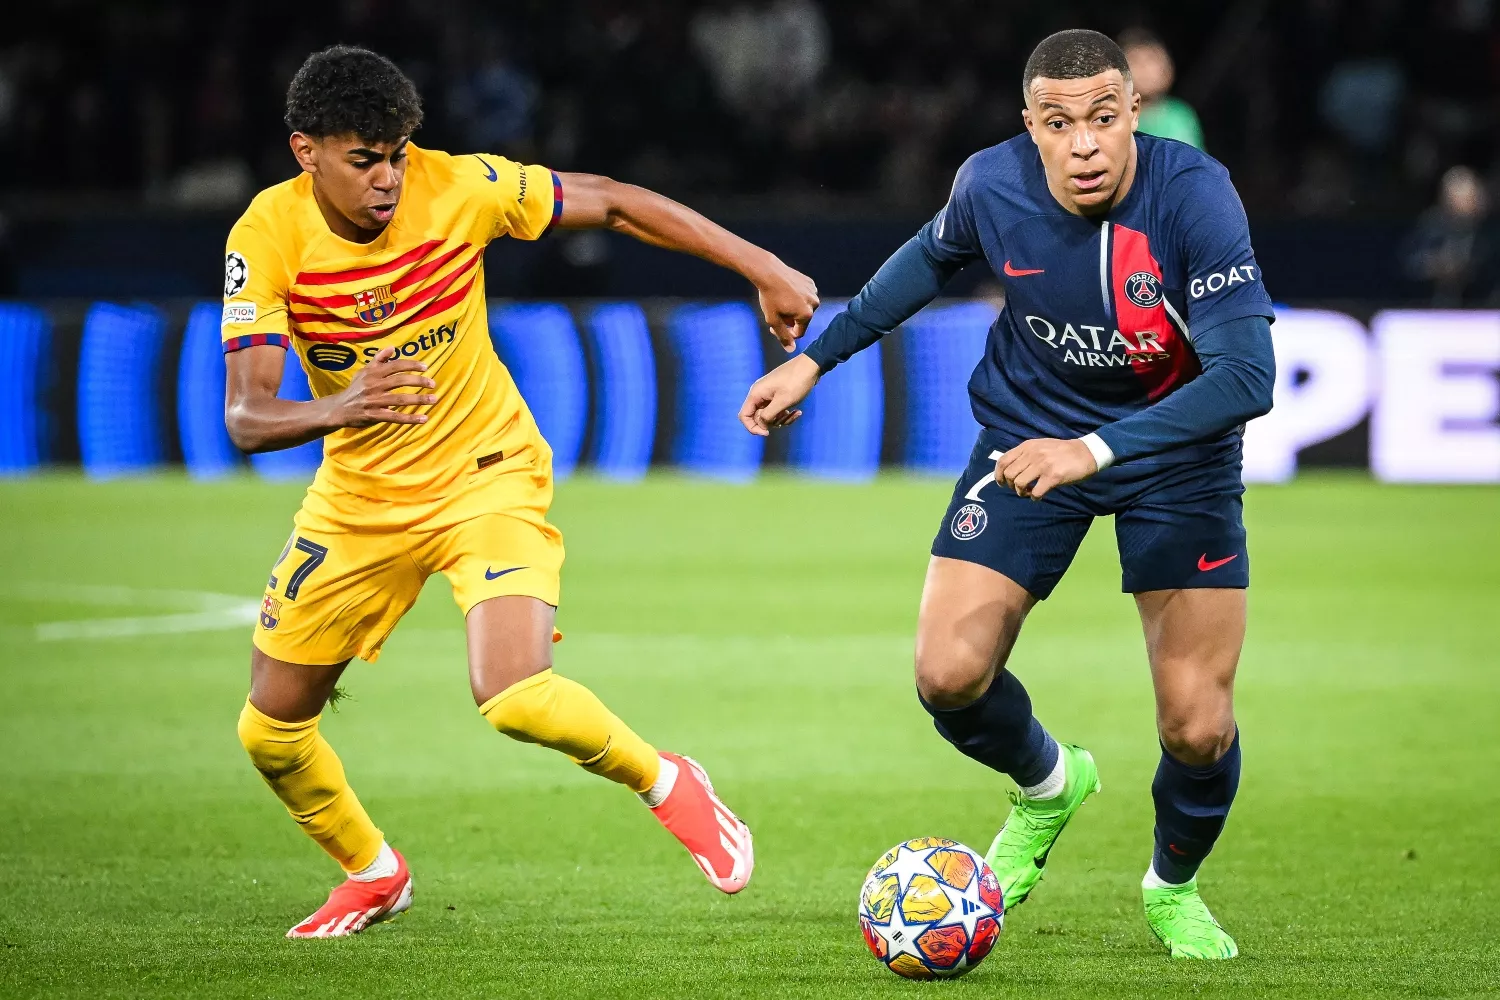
[740, 30, 1275, 958]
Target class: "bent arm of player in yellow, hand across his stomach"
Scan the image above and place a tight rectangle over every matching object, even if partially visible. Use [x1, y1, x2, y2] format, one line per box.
[224, 345, 438, 454]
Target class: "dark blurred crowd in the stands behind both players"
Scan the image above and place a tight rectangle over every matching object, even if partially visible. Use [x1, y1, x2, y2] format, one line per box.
[0, 0, 1500, 303]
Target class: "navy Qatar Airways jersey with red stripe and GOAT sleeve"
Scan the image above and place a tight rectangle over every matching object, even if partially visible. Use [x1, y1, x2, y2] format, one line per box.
[921, 132, 1274, 465]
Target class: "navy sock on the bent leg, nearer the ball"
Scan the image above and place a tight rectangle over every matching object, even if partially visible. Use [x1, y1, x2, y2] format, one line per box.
[917, 670, 1061, 787]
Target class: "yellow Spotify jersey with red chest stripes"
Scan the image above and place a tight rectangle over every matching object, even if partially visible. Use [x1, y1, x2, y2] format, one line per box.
[224, 145, 563, 501]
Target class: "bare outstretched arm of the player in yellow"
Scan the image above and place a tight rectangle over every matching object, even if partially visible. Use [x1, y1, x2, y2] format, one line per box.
[558, 174, 818, 352]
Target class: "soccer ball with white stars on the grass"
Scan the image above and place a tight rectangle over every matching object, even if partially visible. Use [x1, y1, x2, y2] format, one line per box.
[860, 837, 1005, 979]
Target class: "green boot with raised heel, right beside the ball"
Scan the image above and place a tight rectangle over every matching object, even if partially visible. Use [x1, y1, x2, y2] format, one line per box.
[984, 744, 1100, 910]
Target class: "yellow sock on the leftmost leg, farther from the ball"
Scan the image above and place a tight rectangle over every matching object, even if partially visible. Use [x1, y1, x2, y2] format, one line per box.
[240, 702, 386, 871]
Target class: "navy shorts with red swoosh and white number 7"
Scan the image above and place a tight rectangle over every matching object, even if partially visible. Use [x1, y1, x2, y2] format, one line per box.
[933, 430, 1250, 600]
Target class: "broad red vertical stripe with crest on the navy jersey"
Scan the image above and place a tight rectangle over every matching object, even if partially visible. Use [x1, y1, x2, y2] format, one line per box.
[1110, 223, 1203, 399]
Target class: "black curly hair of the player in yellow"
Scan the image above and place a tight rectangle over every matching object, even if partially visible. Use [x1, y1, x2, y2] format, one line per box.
[287, 45, 422, 142]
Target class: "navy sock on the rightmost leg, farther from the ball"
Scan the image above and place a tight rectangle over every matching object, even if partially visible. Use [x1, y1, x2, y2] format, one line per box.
[1151, 730, 1239, 885]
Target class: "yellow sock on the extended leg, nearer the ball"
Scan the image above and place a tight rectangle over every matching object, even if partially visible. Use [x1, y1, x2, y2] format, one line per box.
[479, 670, 662, 792]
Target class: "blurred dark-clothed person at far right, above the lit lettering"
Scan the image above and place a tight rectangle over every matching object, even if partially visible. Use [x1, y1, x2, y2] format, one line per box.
[1407, 166, 1494, 307]
